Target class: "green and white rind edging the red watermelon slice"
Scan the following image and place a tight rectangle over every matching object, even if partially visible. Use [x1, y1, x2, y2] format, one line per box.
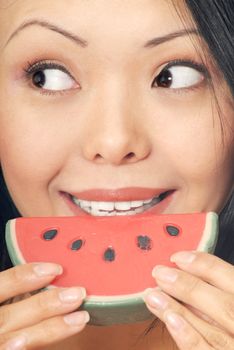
[6, 212, 218, 326]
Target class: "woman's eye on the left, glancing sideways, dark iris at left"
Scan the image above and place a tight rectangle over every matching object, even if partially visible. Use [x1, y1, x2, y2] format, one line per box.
[25, 62, 77, 92]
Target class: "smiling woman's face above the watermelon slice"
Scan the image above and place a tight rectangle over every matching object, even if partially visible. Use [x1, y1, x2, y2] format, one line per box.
[0, 0, 234, 216]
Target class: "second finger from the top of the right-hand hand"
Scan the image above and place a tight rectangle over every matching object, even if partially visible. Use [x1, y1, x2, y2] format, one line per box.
[153, 267, 234, 334]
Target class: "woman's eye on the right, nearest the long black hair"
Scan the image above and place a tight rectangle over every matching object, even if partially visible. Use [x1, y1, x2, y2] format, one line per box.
[152, 61, 207, 89]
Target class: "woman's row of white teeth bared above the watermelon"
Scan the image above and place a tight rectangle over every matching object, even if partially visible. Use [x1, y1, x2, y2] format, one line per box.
[71, 196, 164, 216]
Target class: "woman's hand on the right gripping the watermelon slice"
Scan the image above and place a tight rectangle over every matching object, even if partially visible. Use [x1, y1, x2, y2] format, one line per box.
[145, 252, 234, 350]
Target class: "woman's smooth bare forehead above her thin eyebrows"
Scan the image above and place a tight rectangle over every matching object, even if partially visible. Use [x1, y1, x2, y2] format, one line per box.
[0, 0, 189, 40]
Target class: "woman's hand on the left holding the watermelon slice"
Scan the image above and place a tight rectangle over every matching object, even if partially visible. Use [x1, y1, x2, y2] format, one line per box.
[0, 263, 89, 350]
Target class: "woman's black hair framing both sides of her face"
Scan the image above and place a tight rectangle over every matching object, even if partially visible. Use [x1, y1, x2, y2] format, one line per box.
[0, 0, 234, 270]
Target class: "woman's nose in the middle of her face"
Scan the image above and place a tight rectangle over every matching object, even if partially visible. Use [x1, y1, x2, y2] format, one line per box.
[79, 86, 151, 165]
